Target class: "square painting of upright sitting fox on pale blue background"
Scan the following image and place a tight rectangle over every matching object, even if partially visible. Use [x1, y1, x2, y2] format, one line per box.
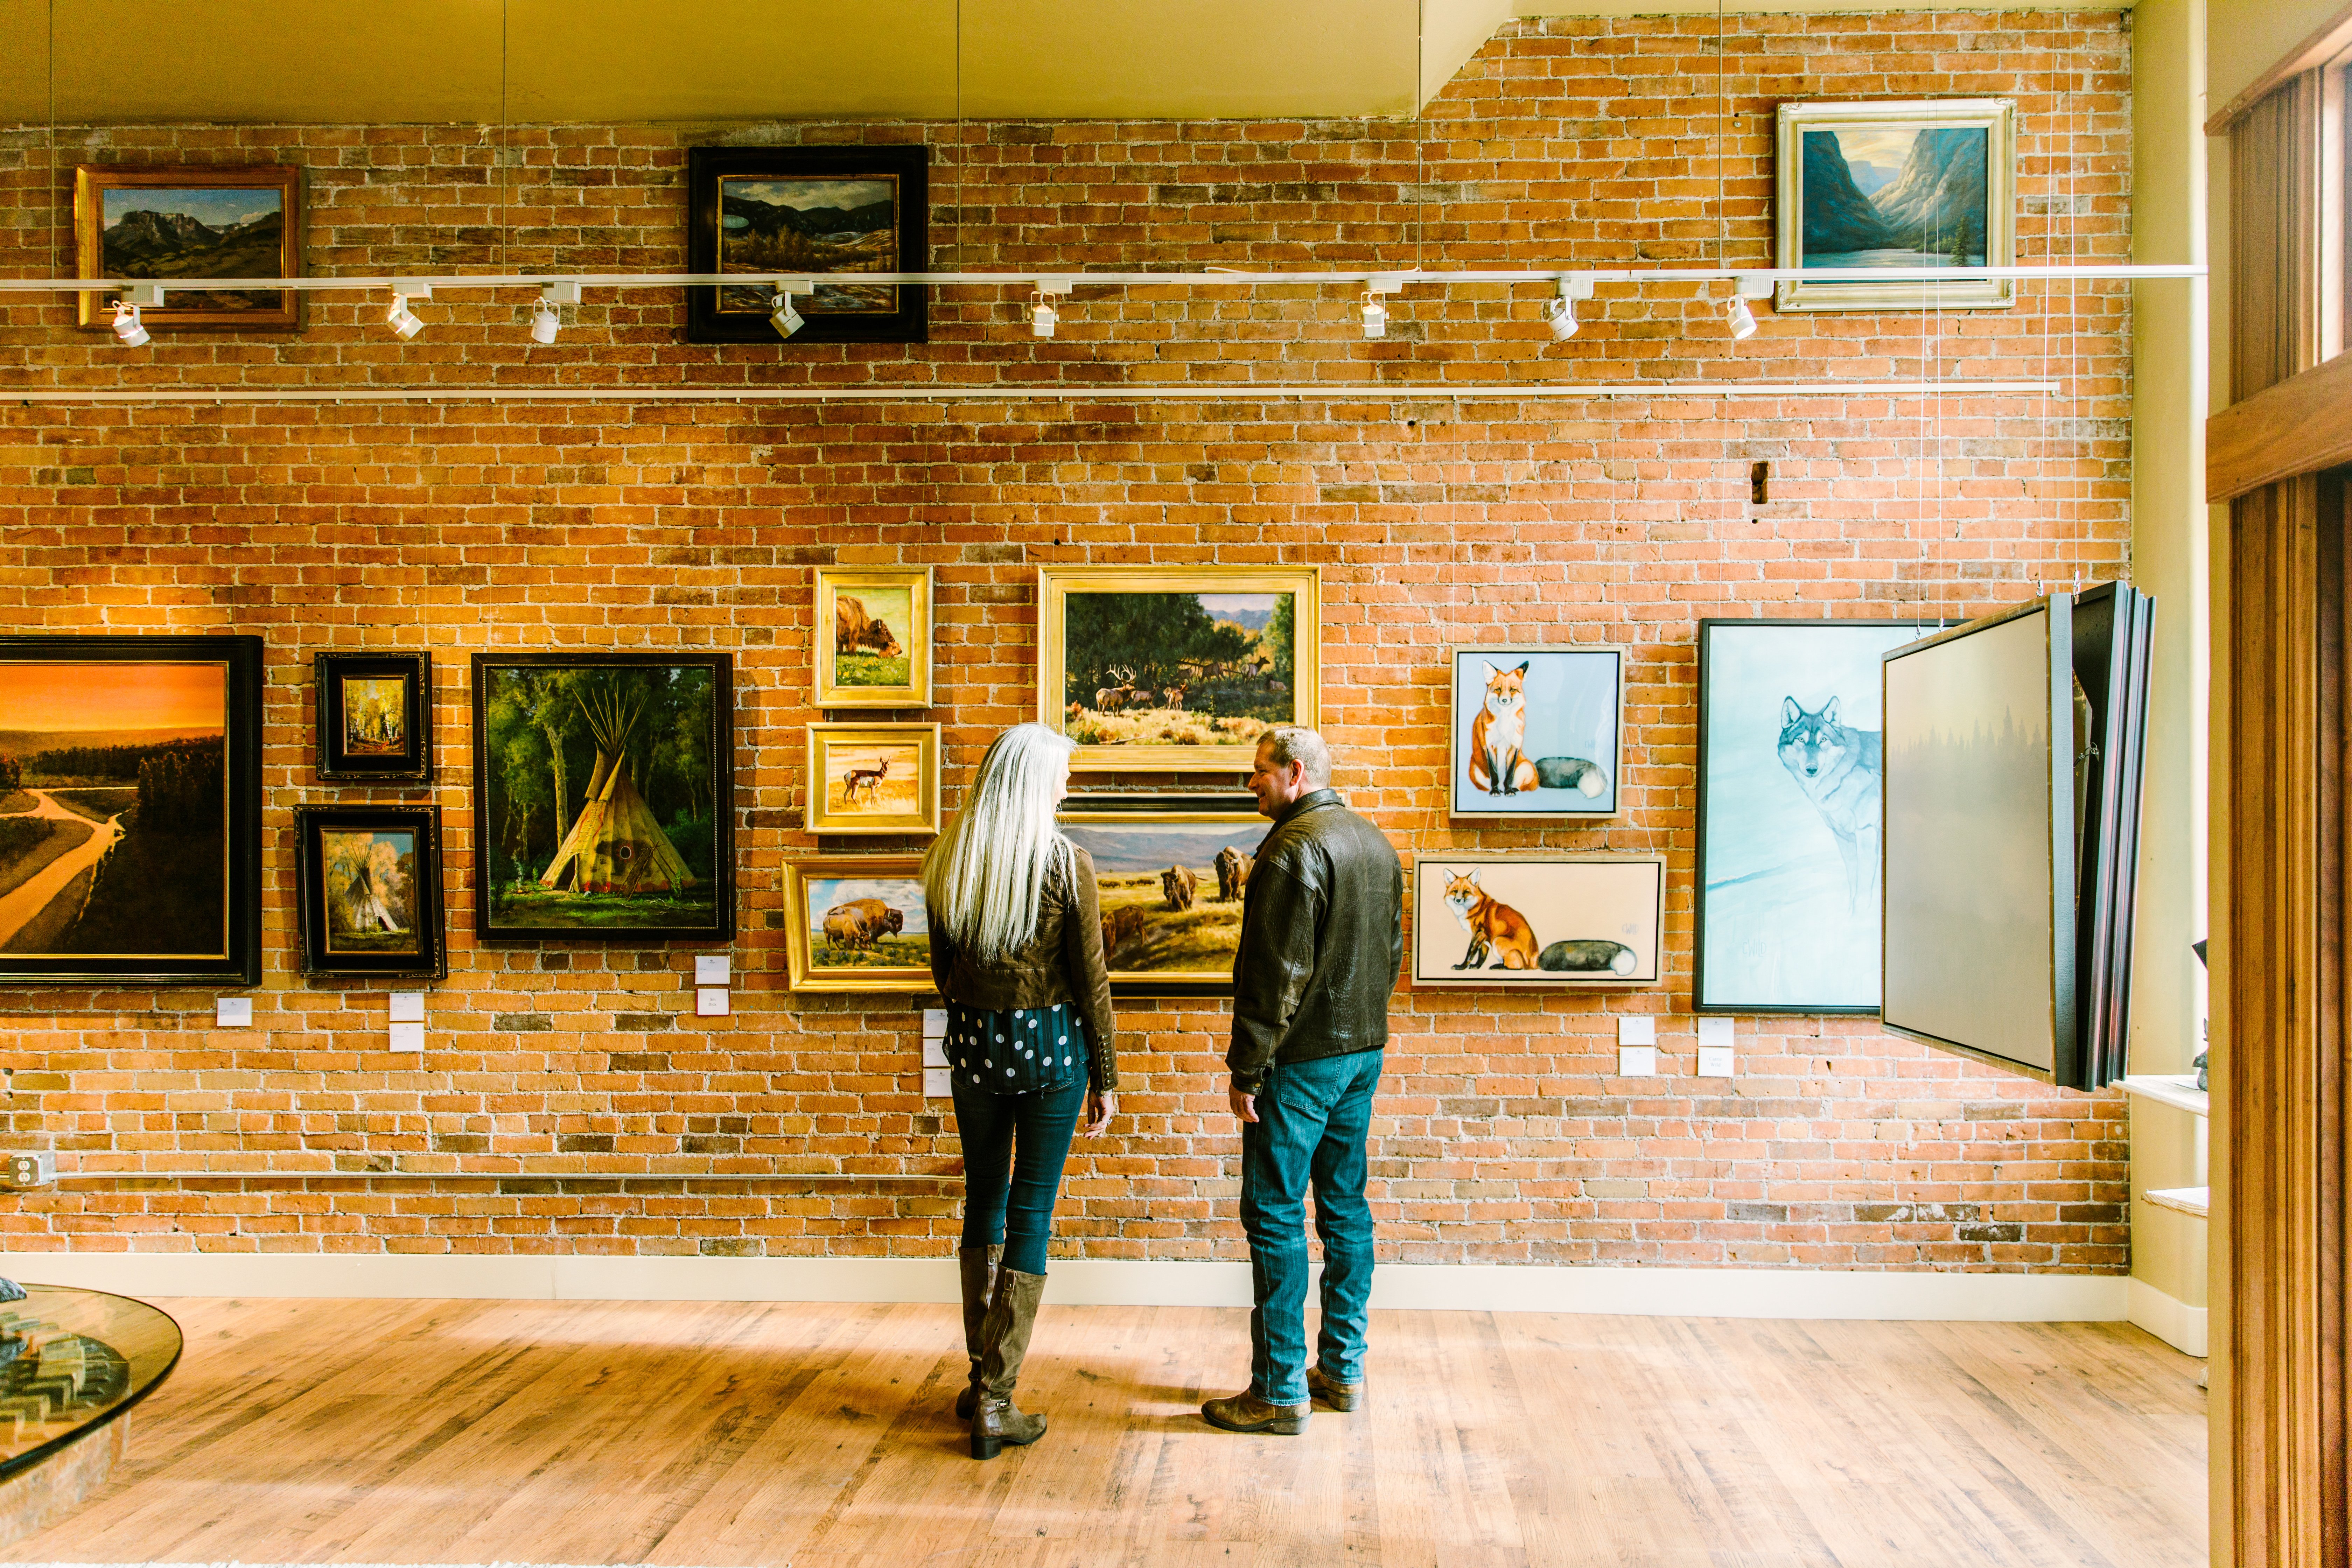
[1449, 644, 1625, 818]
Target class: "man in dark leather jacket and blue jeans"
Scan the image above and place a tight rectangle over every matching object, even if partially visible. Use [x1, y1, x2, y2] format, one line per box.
[1199, 726, 1404, 1434]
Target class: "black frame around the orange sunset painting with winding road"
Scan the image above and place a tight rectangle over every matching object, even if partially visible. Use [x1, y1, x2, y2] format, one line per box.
[0, 635, 264, 987]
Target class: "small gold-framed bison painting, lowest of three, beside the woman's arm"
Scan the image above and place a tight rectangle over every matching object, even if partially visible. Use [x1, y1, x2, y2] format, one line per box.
[783, 856, 931, 992]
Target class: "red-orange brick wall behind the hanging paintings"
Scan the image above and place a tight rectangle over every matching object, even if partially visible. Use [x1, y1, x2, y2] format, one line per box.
[0, 14, 2129, 1272]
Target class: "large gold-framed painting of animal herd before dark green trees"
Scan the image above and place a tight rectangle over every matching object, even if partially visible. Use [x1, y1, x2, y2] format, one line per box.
[1037, 567, 1322, 774]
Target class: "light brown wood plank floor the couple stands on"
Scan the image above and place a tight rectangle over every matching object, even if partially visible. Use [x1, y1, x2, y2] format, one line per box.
[5, 1300, 2206, 1568]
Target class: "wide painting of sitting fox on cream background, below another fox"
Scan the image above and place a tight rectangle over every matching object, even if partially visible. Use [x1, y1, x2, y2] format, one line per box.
[1411, 853, 1665, 990]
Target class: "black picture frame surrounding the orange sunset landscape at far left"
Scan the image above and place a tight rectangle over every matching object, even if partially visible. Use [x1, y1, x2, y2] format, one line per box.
[0, 632, 268, 990]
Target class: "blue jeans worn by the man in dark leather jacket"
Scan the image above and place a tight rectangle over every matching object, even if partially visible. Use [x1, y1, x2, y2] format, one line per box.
[1242, 1051, 1383, 1406]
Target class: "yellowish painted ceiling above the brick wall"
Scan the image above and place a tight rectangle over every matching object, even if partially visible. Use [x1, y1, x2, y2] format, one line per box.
[0, 0, 2129, 125]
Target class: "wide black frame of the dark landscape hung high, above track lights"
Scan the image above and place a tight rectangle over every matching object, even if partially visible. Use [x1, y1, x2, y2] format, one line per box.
[687, 144, 931, 348]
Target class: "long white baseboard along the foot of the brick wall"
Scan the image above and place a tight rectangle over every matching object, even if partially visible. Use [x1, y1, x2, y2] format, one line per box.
[0, 1253, 2135, 1326]
